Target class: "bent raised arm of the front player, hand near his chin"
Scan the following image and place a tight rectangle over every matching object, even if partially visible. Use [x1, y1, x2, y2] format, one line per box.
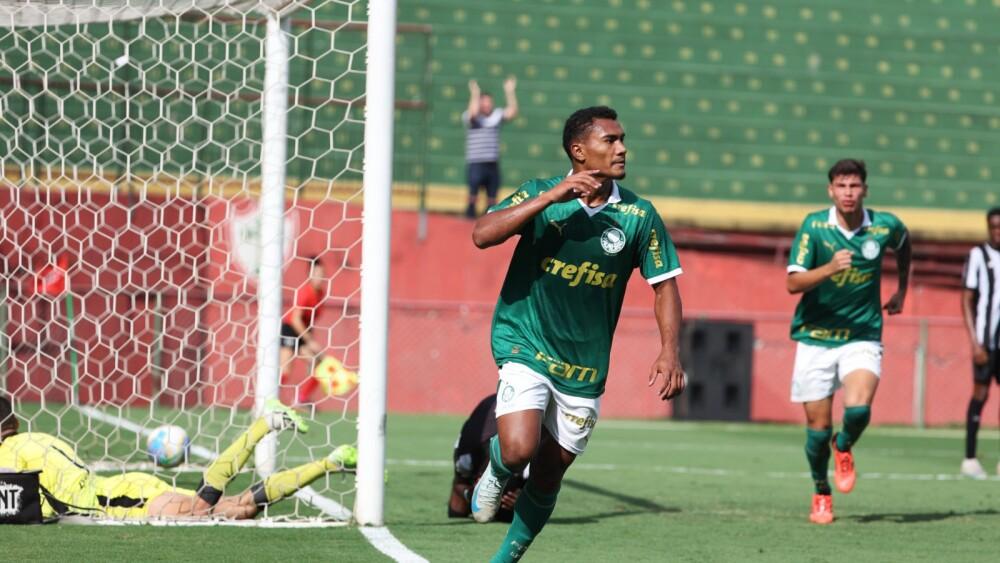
[472, 170, 601, 248]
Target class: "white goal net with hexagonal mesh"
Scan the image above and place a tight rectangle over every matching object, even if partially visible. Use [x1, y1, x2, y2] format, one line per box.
[0, 0, 395, 523]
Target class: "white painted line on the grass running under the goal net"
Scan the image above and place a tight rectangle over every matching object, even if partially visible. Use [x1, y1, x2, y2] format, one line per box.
[76, 407, 427, 563]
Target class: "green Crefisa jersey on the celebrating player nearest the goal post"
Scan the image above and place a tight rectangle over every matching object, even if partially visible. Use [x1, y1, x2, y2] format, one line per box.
[490, 176, 681, 397]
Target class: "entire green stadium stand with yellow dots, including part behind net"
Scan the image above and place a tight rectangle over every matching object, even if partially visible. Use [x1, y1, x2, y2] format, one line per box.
[0, 0, 1000, 221]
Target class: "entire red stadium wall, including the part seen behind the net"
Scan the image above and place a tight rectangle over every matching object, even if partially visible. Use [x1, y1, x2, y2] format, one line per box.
[0, 190, 997, 424]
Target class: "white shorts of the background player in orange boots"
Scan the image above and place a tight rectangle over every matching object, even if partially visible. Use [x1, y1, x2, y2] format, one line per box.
[792, 341, 882, 403]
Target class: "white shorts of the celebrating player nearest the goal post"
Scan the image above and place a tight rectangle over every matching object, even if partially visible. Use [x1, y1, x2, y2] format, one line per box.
[497, 362, 601, 455]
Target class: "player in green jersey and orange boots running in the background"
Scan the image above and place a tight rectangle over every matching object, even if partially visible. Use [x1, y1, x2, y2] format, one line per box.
[787, 159, 910, 524]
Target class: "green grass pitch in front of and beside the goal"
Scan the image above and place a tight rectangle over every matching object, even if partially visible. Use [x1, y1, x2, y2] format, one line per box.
[0, 415, 1000, 563]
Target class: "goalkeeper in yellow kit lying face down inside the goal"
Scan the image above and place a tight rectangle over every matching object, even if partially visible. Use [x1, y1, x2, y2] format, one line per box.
[0, 396, 357, 520]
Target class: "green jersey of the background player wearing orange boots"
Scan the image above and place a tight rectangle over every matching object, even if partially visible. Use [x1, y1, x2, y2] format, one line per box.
[788, 207, 906, 347]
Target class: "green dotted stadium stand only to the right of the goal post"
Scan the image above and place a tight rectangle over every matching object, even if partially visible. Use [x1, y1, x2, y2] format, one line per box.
[399, 0, 1000, 213]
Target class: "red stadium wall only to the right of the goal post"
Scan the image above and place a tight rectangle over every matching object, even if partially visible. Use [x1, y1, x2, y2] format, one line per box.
[389, 213, 997, 425]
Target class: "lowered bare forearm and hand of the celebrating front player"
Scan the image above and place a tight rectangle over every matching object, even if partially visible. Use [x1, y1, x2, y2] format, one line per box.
[649, 278, 684, 401]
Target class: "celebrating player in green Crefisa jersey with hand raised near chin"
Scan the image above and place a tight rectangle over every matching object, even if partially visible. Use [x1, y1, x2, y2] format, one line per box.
[471, 106, 685, 562]
